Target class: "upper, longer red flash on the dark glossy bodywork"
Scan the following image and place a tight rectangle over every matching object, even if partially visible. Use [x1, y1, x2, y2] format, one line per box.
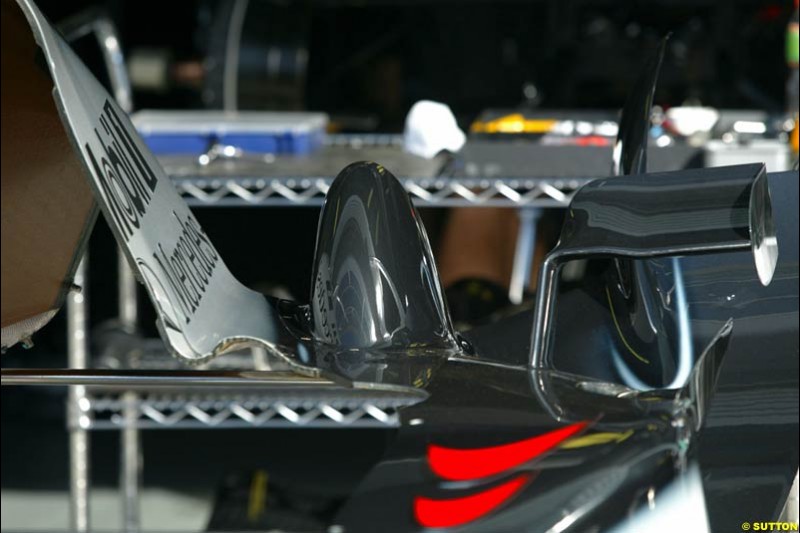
[428, 422, 588, 481]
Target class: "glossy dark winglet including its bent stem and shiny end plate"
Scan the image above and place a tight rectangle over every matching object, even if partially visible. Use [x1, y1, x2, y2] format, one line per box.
[531, 164, 778, 368]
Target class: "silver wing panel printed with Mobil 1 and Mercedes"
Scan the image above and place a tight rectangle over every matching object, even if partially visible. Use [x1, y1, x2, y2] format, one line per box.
[14, 0, 277, 360]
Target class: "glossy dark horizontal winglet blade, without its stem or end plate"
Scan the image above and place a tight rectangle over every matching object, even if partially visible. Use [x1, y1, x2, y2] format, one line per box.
[556, 164, 769, 256]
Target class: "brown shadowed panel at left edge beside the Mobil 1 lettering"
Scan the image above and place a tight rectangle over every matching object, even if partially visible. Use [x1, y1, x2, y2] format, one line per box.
[0, 0, 97, 349]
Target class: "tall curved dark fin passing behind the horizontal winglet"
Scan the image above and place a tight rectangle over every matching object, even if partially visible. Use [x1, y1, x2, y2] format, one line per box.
[601, 36, 694, 390]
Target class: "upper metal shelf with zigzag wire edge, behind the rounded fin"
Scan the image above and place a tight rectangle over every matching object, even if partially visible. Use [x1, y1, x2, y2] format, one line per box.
[161, 135, 590, 207]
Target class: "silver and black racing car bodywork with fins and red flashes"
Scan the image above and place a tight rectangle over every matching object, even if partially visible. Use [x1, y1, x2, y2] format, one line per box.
[2, 0, 798, 532]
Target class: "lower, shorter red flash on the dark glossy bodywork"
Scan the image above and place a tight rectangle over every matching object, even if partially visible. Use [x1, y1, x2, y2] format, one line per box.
[414, 474, 530, 527]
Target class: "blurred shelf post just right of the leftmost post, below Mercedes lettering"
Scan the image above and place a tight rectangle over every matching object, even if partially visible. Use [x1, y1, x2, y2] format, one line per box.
[117, 249, 142, 532]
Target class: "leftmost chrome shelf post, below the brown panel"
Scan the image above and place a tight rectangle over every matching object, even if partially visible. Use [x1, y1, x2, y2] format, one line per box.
[67, 254, 91, 531]
